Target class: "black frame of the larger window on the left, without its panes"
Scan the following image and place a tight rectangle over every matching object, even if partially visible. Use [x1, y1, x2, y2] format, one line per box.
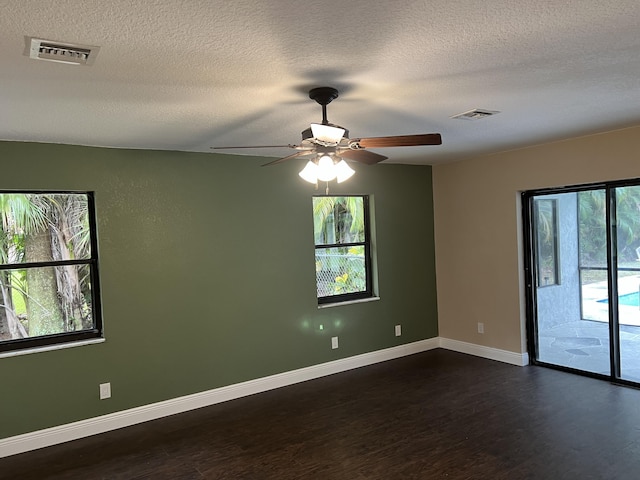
[0, 189, 104, 355]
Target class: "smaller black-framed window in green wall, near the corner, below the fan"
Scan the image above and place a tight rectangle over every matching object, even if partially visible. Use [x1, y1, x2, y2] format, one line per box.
[313, 195, 372, 304]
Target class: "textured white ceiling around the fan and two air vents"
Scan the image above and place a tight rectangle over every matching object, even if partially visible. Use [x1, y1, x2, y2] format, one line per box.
[0, 0, 640, 164]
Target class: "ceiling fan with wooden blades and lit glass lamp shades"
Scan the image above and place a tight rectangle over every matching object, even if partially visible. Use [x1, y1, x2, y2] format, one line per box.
[211, 87, 442, 193]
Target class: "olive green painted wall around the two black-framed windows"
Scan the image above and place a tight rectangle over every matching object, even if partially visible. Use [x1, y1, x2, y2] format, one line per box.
[0, 142, 438, 438]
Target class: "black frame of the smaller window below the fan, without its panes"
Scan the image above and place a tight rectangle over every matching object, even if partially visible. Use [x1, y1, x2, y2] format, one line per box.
[313, 194, 374, 305]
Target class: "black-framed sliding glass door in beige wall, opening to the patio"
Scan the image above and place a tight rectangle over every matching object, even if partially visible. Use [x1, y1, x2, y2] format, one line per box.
[523, 182, 640, 382]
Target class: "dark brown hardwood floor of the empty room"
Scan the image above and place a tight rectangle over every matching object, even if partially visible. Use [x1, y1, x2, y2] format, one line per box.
[0, 350, 640, 480]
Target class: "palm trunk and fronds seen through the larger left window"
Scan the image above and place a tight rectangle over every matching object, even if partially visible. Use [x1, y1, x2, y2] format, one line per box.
[0, 194, 92, 339]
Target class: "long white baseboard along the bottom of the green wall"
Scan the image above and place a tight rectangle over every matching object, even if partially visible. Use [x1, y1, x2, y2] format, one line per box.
[0, 338, 440, 458]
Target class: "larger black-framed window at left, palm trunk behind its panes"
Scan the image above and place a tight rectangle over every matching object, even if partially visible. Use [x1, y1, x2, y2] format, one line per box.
[0, 191, 102, 352]
